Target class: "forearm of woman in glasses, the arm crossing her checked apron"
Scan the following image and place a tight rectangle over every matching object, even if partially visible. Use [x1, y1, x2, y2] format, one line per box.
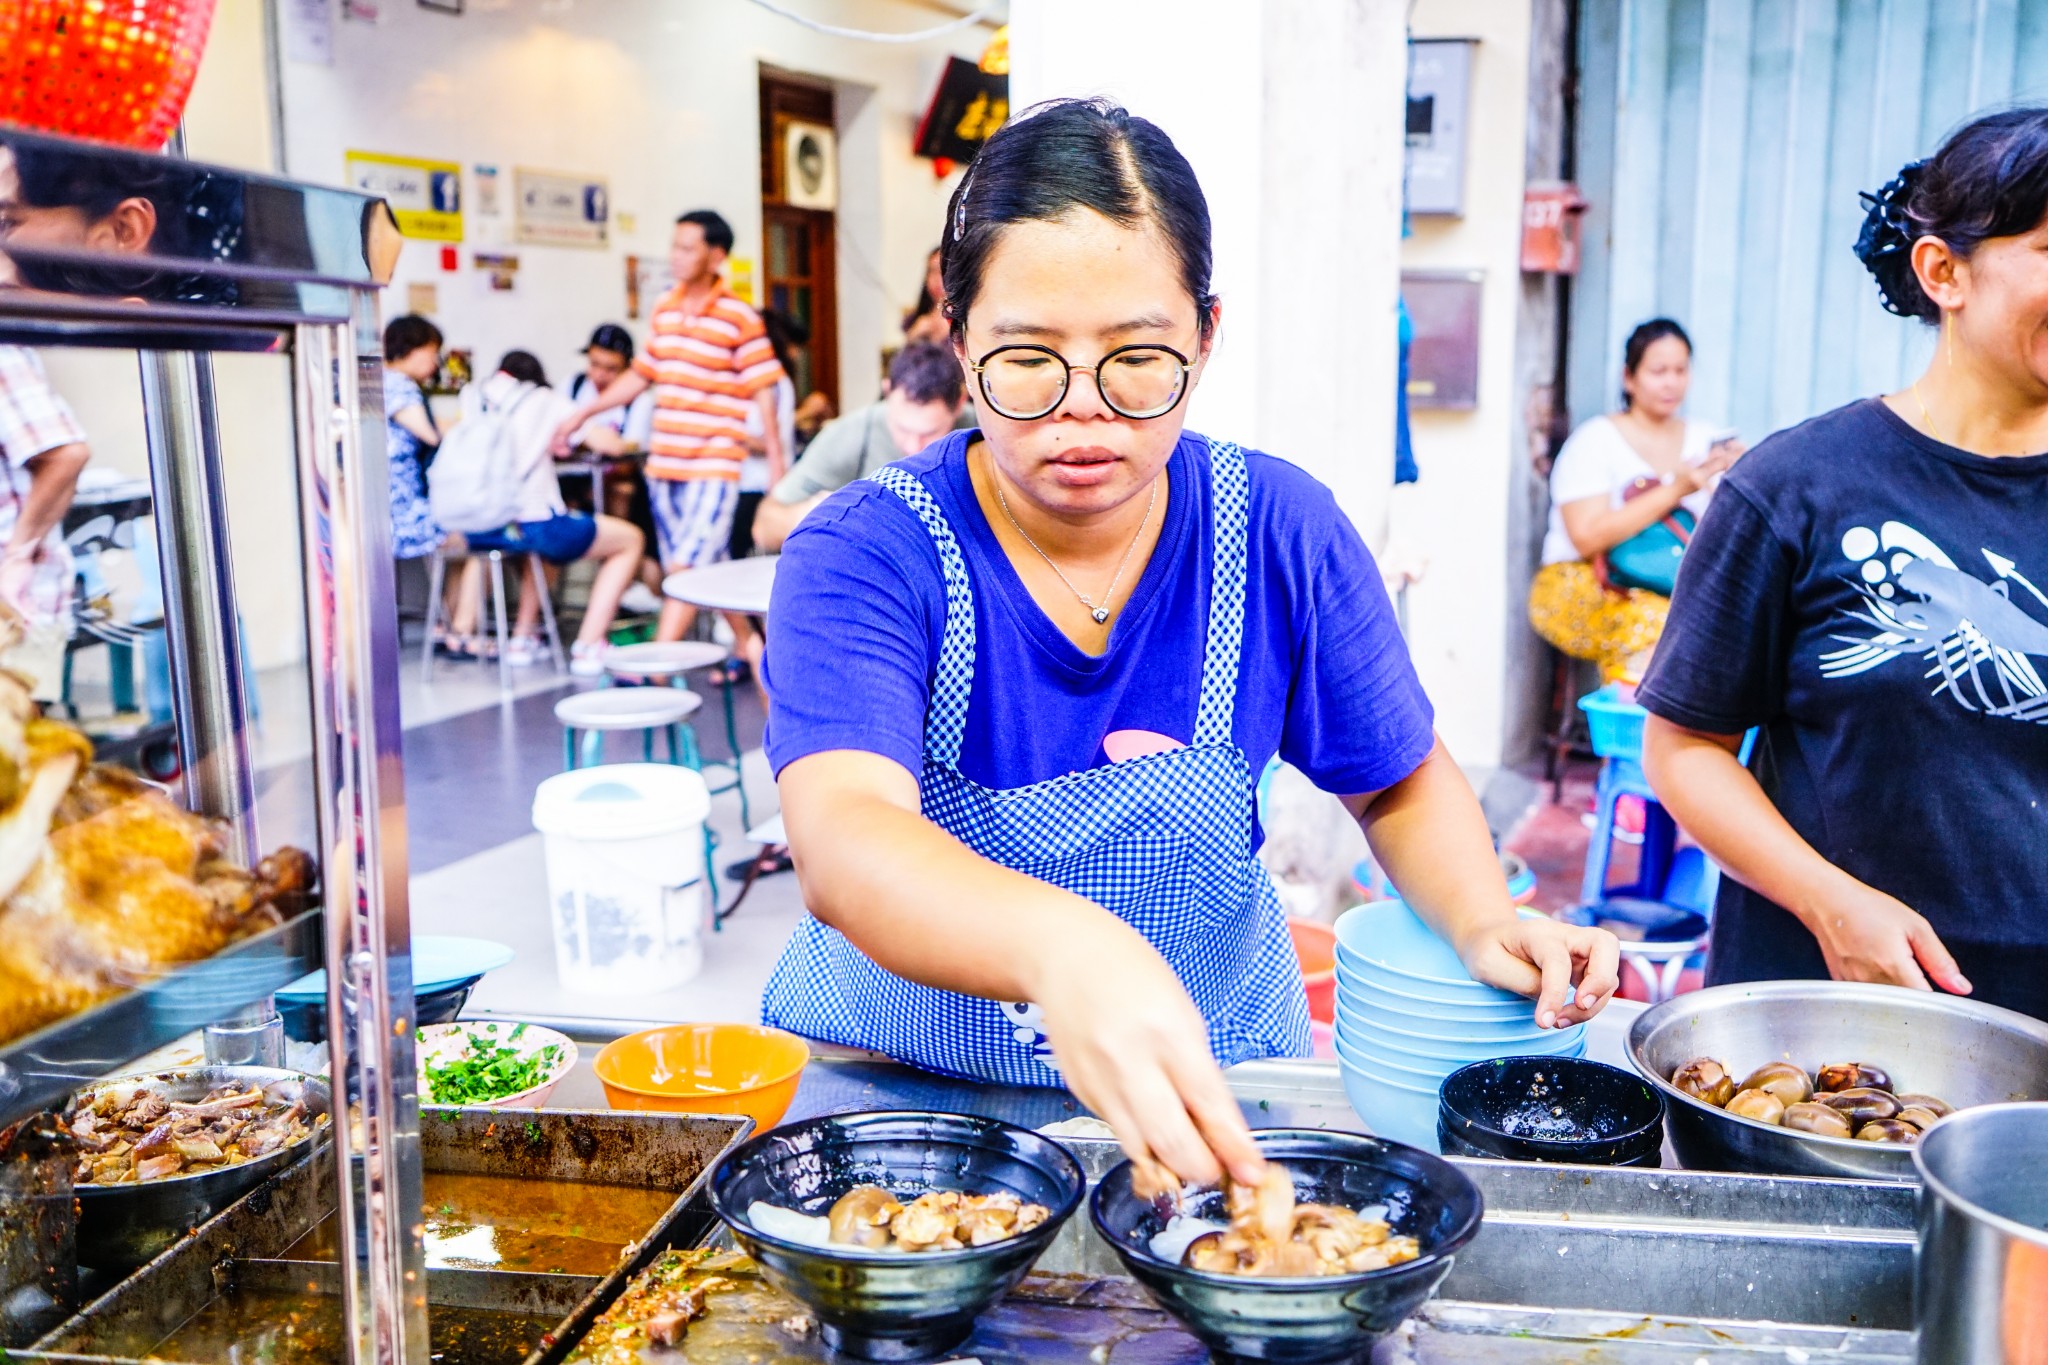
[780, 751, 1151, 1001]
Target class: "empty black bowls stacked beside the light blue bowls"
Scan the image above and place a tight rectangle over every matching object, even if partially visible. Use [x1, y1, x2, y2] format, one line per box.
[1436, 1056, 1663, 1166]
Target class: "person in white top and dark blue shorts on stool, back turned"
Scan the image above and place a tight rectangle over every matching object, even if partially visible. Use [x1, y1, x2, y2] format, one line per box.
[451, 350, 645, 677]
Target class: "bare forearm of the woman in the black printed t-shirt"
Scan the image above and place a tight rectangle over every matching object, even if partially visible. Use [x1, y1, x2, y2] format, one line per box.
[1642, 716, 1851, 925]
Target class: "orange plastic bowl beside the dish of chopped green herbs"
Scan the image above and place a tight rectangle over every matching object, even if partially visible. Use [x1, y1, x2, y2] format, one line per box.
[592, 1023, 811, 1132]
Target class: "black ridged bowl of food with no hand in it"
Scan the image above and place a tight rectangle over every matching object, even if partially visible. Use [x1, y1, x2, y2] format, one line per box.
[711, 1113, 1085, 1361]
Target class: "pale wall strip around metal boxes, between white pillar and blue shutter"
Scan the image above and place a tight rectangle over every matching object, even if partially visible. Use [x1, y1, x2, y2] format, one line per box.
[1389, 0, 1530, 767]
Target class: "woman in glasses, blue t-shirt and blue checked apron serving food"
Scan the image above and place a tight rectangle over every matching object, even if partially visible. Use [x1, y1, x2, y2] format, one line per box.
[762, 102, 1616, 1181]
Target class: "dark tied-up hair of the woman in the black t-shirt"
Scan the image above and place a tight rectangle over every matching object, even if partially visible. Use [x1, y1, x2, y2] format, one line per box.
[1855, 106, 2048, 321]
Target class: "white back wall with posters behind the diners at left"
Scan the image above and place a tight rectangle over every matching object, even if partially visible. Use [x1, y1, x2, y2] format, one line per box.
[25, 0, 987, 667]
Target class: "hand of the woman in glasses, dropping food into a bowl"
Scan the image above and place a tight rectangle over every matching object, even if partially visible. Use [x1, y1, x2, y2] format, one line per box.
[1032, 915, 1266, 1193]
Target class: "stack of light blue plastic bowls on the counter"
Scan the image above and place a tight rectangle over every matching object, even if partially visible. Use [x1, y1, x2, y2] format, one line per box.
[1337, 900, 1585, 1152]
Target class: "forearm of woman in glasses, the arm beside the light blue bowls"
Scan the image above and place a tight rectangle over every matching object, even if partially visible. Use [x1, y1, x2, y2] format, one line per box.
[1346, 739, 1516, 948]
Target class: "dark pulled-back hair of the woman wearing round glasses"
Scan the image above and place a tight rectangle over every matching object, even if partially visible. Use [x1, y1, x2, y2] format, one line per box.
[940, 98, 1217, 336]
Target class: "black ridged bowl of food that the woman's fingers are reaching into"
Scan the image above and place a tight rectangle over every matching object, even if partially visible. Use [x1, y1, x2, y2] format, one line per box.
[1087, 1128, 1483, 1365]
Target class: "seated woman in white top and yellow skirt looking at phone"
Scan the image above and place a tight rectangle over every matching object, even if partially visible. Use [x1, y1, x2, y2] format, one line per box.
[1530, 317, 1743, 681]
